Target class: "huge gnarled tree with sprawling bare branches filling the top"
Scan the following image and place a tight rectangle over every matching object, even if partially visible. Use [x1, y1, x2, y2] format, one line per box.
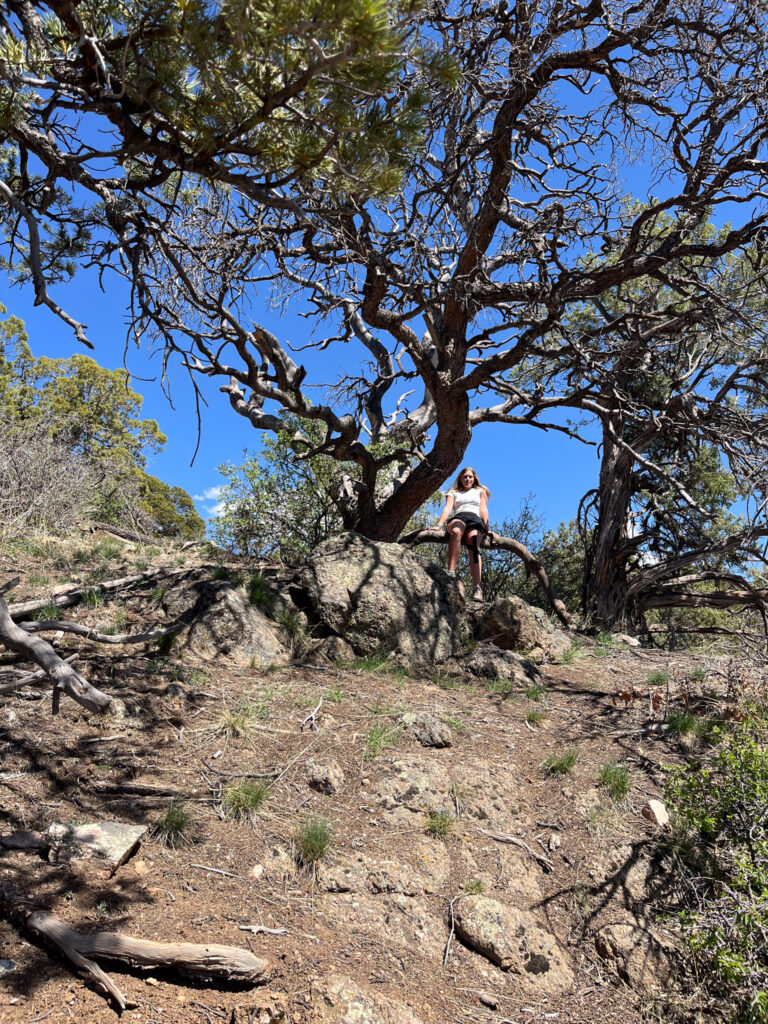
[0, 0, 768, 561]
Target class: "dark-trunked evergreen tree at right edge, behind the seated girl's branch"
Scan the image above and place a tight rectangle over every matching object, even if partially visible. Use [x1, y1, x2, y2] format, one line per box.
[495, 221, 768, 628]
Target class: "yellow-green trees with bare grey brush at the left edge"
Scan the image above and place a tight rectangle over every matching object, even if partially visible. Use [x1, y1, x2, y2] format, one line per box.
[0, 306, 205, 538]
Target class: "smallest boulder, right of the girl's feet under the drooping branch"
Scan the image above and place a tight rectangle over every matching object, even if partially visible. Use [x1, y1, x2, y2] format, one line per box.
[473, 597, 572, 665]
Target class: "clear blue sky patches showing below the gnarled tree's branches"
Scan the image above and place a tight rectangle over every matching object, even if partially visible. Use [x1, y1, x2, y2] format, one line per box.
[0, 262, 598, 528]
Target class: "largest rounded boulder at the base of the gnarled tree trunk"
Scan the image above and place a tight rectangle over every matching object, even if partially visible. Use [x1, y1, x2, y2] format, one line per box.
[296, 534, 461, 665]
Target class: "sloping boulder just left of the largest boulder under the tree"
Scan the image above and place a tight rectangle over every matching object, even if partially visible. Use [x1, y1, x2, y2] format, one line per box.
[161, 572, 289, 668]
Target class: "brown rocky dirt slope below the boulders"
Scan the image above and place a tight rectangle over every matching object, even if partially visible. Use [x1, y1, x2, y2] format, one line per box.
[0, 540, 745, 1024]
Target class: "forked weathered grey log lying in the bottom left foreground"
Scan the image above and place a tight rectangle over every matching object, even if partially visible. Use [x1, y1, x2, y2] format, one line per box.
[27, 910, 270, 1010]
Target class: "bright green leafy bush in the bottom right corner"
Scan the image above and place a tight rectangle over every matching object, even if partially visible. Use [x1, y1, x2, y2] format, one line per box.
[665, 706, 768, 1020]
